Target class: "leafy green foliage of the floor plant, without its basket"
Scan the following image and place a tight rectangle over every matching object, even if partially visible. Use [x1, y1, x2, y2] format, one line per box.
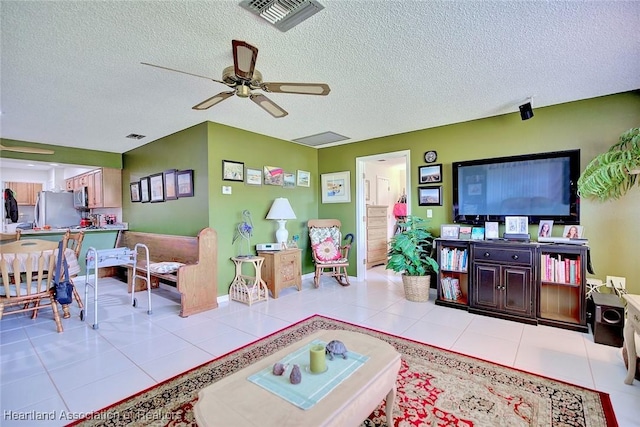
[386, 215, 438, 276]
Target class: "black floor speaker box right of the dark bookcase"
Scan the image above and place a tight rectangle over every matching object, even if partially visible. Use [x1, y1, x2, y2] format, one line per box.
[592, 293, 624, 347]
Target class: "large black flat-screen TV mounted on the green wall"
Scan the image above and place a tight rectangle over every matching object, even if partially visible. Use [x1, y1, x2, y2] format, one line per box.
[453, 150, 580, 225]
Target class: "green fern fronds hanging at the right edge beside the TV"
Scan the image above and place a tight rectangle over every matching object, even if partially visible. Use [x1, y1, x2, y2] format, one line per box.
[578, 128, 640, 201]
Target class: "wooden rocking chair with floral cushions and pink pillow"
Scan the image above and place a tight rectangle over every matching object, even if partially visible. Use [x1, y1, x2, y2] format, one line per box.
[307, 219, 353, 288]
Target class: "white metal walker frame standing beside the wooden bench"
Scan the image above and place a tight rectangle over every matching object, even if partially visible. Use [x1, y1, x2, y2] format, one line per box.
[83, 243, 152, 329]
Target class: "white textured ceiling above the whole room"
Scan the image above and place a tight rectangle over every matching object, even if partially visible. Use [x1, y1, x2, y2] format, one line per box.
[0, 0, 640, 153]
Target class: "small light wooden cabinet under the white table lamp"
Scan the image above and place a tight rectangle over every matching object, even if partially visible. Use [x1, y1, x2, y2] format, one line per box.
[258, 248, 302, 298]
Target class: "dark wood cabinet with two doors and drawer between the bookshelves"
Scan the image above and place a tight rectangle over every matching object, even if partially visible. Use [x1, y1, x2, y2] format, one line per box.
[469, 244, 537, 324]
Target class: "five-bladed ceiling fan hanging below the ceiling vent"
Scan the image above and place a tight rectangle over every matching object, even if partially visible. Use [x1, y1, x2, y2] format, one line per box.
[142, 40, 331, 118]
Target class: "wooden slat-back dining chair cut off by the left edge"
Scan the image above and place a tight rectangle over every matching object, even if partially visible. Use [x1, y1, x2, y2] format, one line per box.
[0, 246, 63, 332]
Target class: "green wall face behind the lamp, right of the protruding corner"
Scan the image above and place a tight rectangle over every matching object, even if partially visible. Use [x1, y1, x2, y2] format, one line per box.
[208, 122, 318, 295]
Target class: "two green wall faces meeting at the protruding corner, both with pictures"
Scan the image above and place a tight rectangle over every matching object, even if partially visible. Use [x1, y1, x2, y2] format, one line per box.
[123, 122, 318, 295]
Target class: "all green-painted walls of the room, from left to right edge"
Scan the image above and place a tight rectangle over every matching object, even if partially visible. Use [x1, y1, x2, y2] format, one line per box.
[2, 91, 640, 295]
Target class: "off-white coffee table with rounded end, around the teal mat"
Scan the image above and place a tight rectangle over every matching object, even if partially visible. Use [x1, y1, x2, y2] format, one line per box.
[194, 330, 400, 427]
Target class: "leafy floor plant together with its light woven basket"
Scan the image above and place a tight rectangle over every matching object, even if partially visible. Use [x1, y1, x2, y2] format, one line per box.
[386, 215, 438, 302]
